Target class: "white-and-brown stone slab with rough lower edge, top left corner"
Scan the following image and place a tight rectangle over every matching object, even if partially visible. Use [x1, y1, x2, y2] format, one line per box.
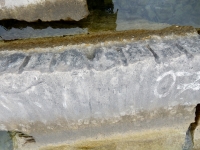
[0, 0, 89, 22]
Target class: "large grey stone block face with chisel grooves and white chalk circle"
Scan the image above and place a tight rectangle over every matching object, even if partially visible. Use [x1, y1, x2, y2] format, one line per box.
[0, 31, 200, 149]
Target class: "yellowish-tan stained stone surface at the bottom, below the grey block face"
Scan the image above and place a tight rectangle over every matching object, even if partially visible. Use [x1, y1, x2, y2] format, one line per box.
[40, 128, 186, 150]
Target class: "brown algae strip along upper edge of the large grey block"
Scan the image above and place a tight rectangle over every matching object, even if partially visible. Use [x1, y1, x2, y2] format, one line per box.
[0, 26, 197, 50]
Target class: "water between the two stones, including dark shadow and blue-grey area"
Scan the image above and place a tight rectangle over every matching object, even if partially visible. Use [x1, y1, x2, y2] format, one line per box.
[0, 0, 200, 40]
